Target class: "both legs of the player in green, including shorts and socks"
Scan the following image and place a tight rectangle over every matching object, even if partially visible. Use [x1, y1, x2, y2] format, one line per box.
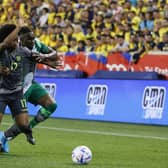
[2, 83, 57, 143]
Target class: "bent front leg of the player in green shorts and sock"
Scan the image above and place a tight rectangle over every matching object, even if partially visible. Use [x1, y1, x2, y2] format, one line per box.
[25, 83, 57, 128]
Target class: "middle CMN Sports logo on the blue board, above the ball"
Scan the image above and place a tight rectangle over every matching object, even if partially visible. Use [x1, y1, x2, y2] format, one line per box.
[86, 85, 108, 115]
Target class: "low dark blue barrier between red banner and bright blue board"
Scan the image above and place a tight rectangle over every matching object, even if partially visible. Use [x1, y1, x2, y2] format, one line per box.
[36, 69, 161, 80]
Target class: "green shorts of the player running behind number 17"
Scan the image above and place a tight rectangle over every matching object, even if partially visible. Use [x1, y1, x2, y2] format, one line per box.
[24, 82, 48, 105]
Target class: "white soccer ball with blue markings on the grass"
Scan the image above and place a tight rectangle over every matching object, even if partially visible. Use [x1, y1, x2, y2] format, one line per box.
[72, 145, 92, 164]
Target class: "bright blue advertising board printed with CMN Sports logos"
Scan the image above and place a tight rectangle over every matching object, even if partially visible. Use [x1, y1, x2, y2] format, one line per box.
[4, 77, 168, 125]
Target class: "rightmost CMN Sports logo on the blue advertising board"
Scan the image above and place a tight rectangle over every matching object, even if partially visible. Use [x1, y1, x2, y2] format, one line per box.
[142, 86, 166, 119]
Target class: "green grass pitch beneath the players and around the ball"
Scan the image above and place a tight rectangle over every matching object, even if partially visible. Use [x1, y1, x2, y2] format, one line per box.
[0, 115, 168, 168]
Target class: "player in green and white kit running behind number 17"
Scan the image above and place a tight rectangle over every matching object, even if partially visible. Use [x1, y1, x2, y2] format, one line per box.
[1, 27, 62, 151]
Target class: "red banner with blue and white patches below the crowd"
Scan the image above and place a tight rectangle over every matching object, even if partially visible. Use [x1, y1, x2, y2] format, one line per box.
[38, 52, 168, 79]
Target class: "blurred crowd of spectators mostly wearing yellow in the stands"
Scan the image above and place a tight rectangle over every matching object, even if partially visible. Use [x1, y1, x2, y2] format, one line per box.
[0, 0, 168, 59]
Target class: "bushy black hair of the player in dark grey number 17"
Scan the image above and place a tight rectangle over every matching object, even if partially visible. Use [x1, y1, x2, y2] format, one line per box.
[0, 24, 16, 43]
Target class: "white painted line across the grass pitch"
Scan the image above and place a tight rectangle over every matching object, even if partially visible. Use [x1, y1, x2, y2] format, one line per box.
[2, 122, 168, 140]
